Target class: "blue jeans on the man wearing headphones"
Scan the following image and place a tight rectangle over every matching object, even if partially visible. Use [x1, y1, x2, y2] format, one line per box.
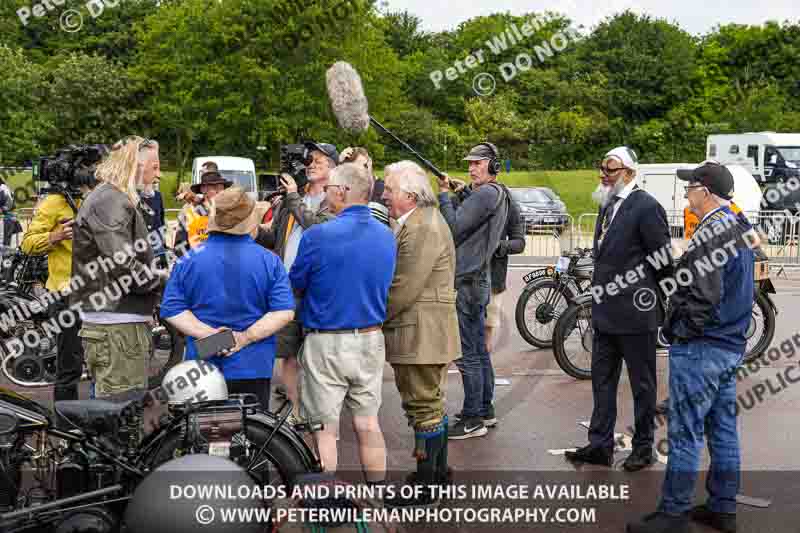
[456, 275, 494, 419]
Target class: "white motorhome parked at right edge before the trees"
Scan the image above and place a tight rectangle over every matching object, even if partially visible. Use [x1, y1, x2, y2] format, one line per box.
[706, 131, 800, 183]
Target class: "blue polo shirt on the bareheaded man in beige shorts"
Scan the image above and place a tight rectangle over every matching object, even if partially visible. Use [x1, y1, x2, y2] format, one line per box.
[289, 205, 397, 329]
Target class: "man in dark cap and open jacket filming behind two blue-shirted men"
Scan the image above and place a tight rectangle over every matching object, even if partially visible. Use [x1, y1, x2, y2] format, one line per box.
[256, 142, 339, 421]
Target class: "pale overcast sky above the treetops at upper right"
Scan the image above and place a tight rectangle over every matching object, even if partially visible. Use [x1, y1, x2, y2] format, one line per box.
[383, 0, 800, 34]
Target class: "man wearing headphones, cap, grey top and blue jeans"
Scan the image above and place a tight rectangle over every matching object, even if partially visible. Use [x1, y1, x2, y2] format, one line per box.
[439, 143, 511, 440]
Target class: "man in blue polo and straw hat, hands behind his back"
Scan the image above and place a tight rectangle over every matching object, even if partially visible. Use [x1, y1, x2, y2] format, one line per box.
[161, 187, 294, 409]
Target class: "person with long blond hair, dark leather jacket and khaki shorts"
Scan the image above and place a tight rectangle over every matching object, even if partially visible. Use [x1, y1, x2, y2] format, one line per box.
[71, 136, 167, 400]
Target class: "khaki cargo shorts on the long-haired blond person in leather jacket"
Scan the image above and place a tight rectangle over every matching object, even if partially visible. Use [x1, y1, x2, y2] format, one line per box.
[78, 322, 153, 398]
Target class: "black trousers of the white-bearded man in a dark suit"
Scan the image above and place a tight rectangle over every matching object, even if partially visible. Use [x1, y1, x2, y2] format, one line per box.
[589, 330, 657, 449]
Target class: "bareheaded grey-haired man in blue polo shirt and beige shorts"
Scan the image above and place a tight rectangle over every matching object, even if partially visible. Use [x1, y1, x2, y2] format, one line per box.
[289, 163, 396, 483]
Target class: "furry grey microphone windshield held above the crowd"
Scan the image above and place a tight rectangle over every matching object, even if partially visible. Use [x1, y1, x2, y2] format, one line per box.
[326, 61, 369, 133]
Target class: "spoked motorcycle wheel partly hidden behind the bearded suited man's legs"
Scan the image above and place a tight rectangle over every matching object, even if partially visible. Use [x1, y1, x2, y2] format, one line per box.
[553, 301, 594, 379]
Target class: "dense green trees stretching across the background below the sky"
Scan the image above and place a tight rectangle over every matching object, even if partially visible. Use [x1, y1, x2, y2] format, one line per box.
[0, 0, 800, 189]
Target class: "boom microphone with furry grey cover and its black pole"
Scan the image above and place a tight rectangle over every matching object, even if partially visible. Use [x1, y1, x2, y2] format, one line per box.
[325, 61, 444, 178]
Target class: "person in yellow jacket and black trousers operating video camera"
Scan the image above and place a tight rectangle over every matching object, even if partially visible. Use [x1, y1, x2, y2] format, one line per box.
[21, 164, 95, 401]
